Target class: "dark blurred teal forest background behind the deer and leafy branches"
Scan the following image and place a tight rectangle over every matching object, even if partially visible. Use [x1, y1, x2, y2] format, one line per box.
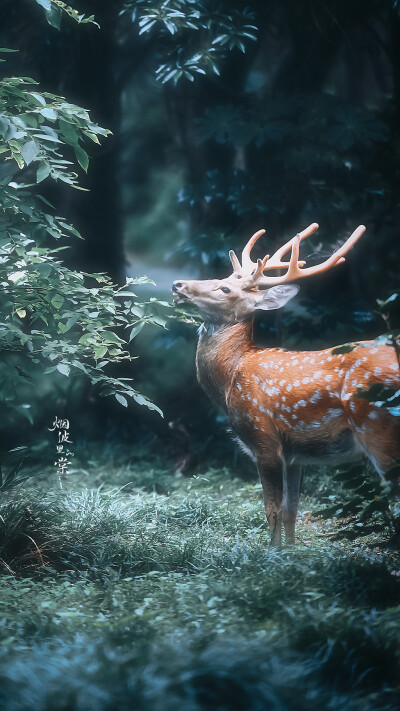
[0, 0, 400, 473]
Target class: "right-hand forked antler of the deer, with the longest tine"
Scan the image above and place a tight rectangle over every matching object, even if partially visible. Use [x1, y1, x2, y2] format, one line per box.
[248, 223, 366, 286]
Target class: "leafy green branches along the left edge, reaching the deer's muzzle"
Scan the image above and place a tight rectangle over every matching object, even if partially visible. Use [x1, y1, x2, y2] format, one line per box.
[0, 57, 169, 419]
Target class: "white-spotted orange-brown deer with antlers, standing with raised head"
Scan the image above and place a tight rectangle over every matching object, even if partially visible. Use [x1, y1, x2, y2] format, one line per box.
[172, 223, 400, 546]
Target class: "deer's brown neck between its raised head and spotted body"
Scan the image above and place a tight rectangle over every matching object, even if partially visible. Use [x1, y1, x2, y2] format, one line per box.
[196, 320, 254, 409]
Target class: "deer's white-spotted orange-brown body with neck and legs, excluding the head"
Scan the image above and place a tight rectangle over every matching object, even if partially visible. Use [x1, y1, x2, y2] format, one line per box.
[196, 320, 400, 542]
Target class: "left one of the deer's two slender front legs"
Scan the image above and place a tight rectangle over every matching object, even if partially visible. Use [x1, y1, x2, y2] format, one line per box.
[258, 459, 283, 546]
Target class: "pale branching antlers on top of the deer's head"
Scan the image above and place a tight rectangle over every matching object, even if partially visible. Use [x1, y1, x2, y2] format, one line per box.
[229, 222, 366, 288]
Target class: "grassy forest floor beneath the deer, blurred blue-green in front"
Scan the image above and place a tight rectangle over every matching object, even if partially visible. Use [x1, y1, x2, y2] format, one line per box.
[0, 451, 400, 711]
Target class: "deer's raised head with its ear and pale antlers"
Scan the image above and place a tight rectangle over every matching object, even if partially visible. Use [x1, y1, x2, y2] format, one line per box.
[172, 222, 365, 324]
